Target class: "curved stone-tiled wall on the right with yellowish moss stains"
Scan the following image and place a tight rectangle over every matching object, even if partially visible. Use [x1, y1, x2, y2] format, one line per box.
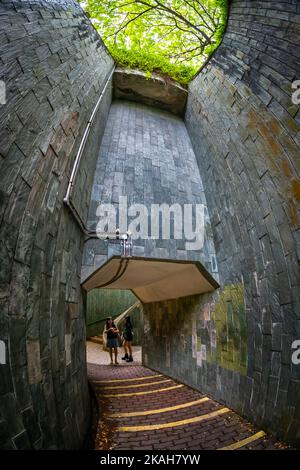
[145, 0, 300, 446]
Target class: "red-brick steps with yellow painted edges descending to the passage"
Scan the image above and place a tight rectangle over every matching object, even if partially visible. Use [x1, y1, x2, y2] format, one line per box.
[88, 348, 286, 450]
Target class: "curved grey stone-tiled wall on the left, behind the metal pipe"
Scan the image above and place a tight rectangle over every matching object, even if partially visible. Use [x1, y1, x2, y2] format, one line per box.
[0, 0, 113, 449]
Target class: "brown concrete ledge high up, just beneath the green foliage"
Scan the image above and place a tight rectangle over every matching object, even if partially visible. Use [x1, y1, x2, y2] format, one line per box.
[113, 68, 188, 116]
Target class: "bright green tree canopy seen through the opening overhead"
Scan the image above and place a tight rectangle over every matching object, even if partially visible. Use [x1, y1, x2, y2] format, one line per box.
[80, 0, 228, 84]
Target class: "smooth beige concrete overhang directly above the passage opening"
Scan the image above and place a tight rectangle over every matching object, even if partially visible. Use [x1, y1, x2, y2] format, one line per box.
[82, 256, 220, 303]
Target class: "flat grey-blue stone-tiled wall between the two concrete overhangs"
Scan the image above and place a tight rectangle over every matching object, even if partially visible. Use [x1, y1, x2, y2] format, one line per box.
[82, 100, 217, 279]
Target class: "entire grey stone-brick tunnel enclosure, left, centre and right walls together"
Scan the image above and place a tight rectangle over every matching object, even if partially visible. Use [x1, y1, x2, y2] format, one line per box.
[0, 0, 300, 449]
